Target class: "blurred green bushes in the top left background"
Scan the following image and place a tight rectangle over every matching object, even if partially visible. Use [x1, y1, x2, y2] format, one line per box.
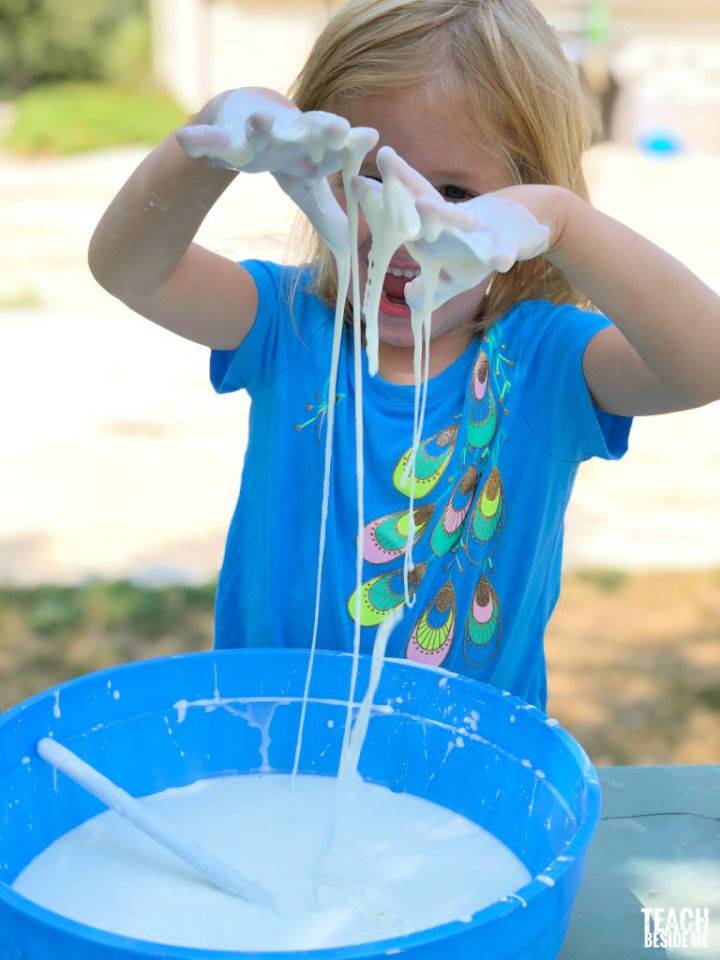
[0, 0, 185, 154]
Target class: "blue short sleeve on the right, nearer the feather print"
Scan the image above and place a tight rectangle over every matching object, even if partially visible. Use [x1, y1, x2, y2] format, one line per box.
[522, 301, 632, 463]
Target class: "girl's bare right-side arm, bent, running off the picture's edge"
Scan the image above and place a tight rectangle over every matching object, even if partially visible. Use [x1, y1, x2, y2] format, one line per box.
[544, 187, 720, 416]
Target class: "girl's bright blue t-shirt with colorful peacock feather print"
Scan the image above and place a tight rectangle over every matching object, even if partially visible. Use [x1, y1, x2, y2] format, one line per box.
[210, 261, 631, 709]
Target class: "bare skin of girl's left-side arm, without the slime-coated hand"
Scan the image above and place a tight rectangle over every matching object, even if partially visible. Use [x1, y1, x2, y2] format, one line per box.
[88, 91, 257, 349]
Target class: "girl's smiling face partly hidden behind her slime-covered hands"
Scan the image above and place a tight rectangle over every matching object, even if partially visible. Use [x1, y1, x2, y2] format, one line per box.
[331, 83, 512, 364]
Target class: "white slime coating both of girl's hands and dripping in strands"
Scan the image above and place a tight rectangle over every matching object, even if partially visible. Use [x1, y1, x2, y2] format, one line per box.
[178, 90, 550, 812]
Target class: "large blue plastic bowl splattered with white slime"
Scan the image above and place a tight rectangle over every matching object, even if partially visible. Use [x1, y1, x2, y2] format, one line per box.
[0, 649, 600, 960]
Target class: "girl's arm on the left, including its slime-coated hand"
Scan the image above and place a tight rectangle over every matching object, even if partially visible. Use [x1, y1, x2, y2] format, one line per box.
[88, 87, 377, 350]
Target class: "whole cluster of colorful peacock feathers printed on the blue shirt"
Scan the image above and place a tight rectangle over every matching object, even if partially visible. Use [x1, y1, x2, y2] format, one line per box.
[346, 324, 515, 670]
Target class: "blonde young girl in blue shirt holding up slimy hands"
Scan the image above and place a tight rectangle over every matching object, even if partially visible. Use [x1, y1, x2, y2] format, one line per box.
[90, 0, 720, 709]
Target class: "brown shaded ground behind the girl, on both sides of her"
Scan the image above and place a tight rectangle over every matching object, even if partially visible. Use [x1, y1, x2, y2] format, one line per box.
[0, 570, 720, 765]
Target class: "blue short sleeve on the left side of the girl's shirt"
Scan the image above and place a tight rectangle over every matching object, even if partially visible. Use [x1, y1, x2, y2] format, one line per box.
[210, 260, 303, 393]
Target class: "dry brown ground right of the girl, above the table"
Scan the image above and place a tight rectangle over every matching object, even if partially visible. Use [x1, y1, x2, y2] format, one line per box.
[546, 570, 720, 764]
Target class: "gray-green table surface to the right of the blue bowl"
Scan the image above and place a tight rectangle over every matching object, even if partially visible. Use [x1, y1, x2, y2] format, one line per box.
[559, 765, 720, 960]
